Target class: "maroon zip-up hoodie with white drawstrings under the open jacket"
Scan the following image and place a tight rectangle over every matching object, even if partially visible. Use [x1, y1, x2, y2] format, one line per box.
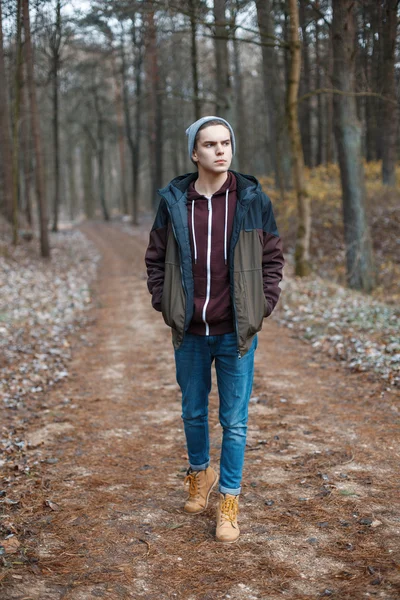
[187, 171, 237, 335]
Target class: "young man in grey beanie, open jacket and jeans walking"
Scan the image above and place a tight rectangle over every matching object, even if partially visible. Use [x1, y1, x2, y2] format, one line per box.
[145, 116, 284, 543]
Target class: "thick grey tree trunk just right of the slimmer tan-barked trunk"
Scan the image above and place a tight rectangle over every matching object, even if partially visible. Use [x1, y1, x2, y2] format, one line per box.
[332, 0, 375, 292]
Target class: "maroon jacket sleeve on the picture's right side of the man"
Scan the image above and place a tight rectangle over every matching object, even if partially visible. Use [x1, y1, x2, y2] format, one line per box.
[262, 193, 285, 317]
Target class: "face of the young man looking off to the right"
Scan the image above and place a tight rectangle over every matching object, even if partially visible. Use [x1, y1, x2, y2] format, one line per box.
[192, 125, 232, 174]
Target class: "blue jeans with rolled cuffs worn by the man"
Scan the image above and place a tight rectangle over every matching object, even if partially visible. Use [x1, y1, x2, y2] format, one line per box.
[175, 333, 258, 495]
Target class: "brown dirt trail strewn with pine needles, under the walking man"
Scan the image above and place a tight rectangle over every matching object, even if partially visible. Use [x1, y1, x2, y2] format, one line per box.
[0, 223, 400, 600]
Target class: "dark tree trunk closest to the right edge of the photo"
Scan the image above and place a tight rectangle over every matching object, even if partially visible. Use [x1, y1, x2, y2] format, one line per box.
[381, 0, 398, 187]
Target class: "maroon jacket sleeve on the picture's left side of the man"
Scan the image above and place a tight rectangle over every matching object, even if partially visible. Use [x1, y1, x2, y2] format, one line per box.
[144, 199, 169, 312]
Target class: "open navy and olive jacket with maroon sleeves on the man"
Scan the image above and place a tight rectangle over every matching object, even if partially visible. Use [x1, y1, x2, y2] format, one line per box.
[145, 171, 284, 356]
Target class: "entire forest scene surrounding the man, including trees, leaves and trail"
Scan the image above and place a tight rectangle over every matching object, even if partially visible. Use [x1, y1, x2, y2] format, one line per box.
[0, 0, 400, 600]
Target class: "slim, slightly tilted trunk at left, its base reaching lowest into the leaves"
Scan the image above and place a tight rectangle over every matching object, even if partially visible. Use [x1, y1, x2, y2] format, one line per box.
[22, 0, 50, 258]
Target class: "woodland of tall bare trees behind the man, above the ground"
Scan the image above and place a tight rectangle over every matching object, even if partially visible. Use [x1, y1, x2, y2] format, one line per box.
[0, 0, 399, 292]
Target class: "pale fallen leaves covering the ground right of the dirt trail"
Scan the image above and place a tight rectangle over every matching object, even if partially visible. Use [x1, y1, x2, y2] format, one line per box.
[279, 276, 400, 391]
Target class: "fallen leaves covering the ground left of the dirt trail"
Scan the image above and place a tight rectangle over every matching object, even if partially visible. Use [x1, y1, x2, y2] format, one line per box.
[0, 225, 100, 579]
